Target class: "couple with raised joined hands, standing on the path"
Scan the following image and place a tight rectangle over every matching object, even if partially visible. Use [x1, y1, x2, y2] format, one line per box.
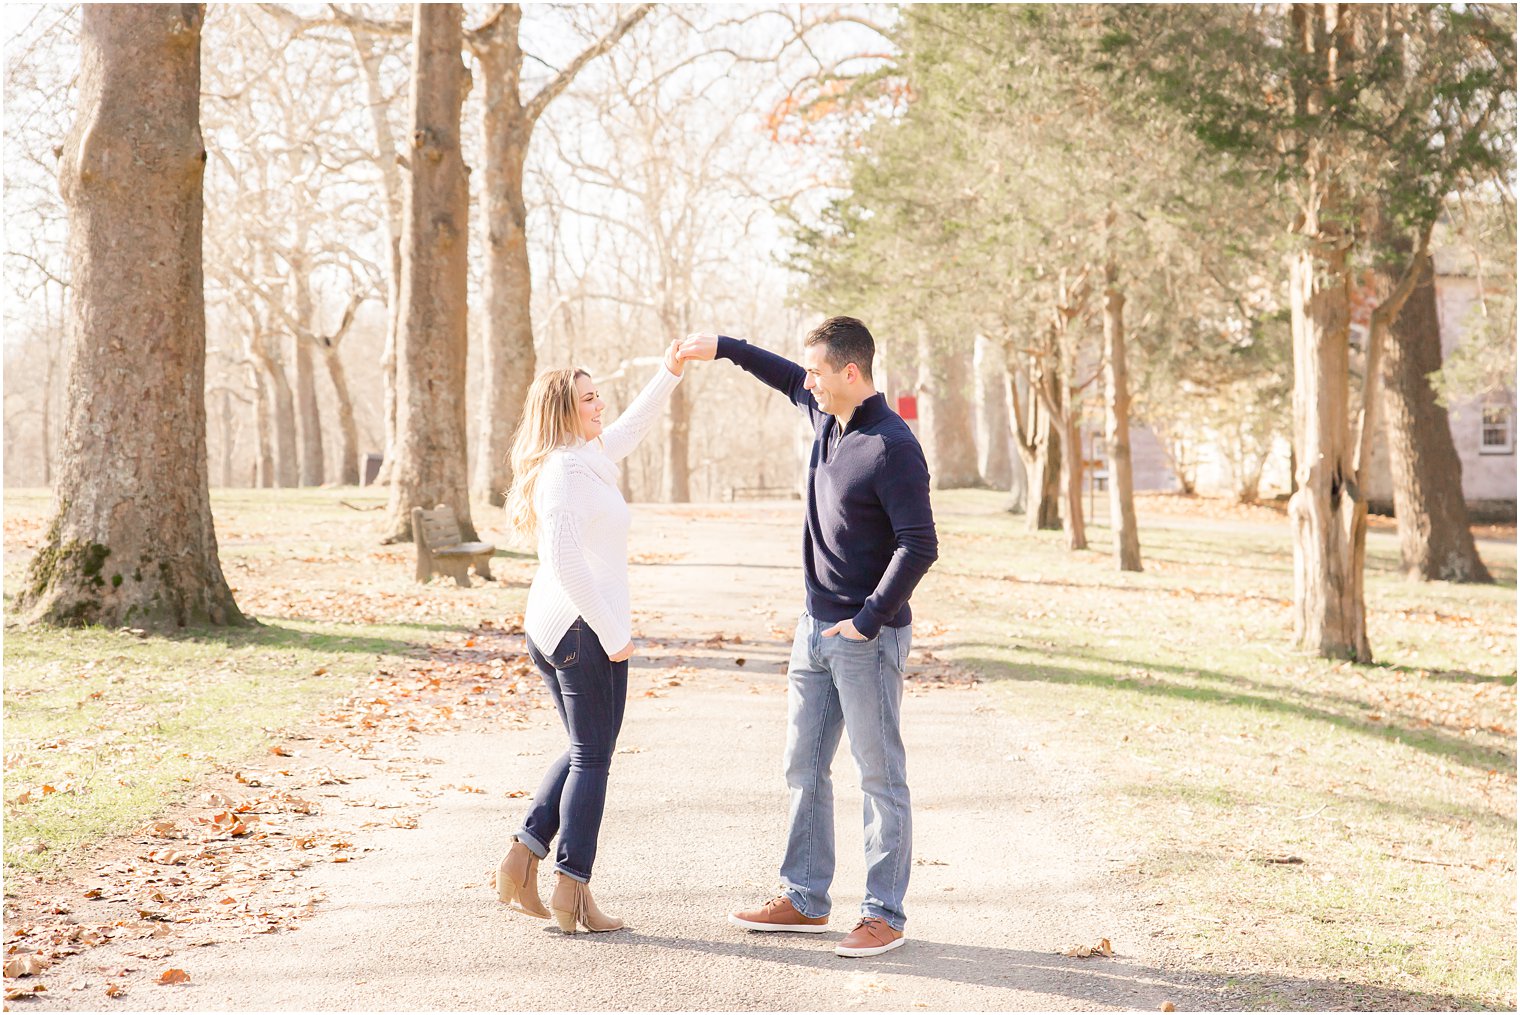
[496, 318, 938, 956]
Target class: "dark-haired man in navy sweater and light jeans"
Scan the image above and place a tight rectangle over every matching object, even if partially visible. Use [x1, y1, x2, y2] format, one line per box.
[681, 318, 939, 956]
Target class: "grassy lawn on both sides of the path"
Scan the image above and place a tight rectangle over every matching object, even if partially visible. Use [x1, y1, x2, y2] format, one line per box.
[5, 489, 1515, 1009]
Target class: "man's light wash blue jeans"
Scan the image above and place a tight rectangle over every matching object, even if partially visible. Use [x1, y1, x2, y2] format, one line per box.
[781, 614, 914, 930]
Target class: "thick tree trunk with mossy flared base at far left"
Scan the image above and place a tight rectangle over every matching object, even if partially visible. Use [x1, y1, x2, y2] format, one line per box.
[17, 5, 245, 629]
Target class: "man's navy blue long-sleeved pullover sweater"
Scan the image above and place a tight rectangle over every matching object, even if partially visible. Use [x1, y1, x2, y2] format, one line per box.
[717, 336, 939, 638]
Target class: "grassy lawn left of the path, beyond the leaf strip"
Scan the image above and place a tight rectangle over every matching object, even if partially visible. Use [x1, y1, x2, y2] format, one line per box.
[5, 489, 526, 883]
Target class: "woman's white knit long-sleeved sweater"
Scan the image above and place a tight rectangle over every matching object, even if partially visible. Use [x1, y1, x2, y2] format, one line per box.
[523, 366, 681, 655]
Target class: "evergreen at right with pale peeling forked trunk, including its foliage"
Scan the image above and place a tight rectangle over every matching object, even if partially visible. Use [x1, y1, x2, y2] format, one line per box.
[1107, 3, 1515, 662]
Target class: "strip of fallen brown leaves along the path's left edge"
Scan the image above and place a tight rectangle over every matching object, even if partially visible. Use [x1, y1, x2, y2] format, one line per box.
[5, 617, 546, 1001]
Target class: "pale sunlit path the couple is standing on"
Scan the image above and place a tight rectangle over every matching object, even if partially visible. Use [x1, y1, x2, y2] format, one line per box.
[23, 504, 1221, 1010]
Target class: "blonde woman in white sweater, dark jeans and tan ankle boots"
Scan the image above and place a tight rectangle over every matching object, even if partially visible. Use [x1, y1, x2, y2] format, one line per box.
[496, 342, 684, 933]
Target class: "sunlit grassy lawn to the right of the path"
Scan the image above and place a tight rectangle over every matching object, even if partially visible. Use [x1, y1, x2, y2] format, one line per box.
[920, 491, 1515, 1009]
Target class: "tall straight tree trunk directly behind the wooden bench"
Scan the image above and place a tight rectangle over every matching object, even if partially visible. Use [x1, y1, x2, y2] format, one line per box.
[386, 3, 477, 542]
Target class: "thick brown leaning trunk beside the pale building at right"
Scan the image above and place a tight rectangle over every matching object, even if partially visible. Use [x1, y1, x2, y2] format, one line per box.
[1383, 254, 1493, 582]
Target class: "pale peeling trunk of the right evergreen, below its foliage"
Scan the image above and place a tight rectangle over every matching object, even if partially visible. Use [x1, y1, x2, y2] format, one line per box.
[1287, 243, 1373, 662]
